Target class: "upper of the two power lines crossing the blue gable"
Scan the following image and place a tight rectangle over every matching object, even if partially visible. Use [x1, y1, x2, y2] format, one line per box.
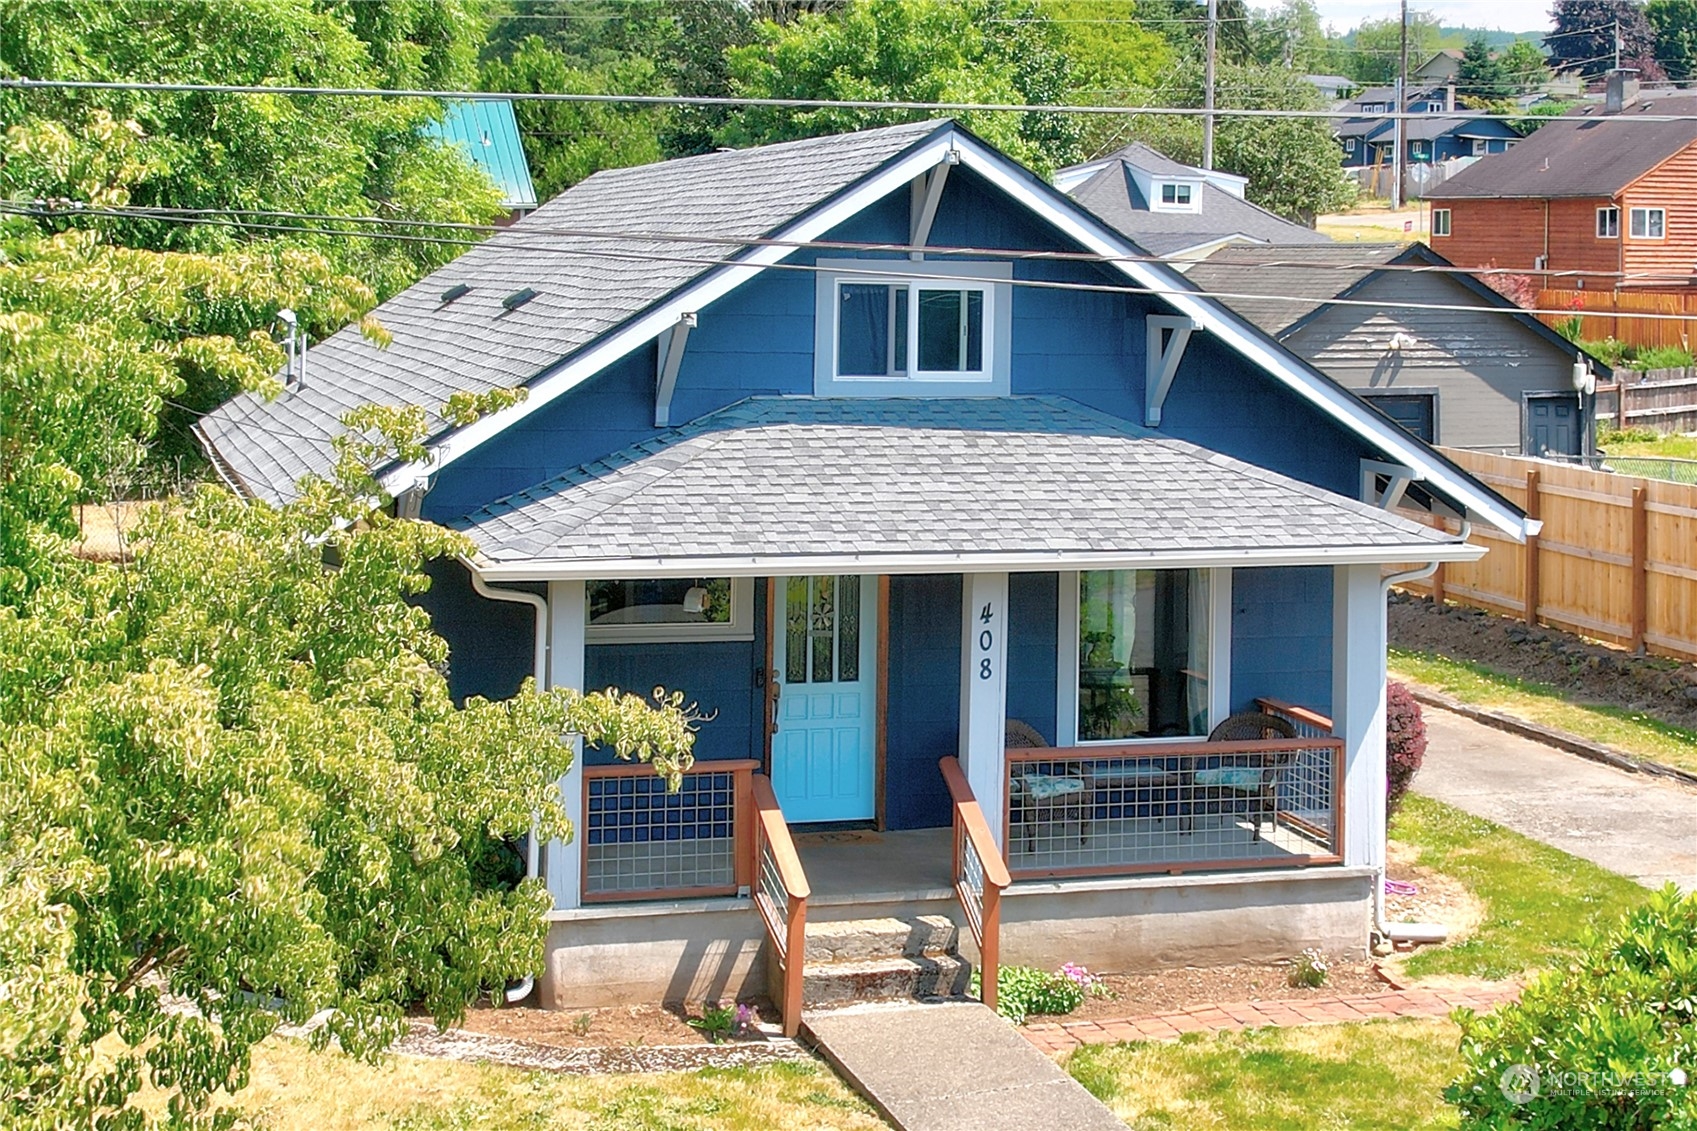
[16, 200, 1690, 284]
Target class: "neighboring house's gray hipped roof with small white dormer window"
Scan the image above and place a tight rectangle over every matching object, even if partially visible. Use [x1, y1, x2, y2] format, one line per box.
[1054, 141, 1330, 258]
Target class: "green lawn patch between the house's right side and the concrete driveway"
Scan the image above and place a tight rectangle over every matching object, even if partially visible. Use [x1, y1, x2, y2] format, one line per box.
[1390, 791, 1649, 978]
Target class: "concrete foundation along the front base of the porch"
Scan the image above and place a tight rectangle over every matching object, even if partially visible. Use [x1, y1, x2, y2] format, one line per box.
[538, 868, 1373, 1009]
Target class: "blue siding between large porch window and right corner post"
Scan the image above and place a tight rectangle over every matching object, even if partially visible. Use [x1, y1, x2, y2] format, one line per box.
[1232, 566, 1332, 715]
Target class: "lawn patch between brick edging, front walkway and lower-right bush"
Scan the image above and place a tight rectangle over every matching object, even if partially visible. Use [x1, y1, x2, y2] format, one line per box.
[1066, 1019, 1461, 1131]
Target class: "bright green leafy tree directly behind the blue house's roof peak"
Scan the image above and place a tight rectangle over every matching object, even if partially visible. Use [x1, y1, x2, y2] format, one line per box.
[718, 0, 1079, 172]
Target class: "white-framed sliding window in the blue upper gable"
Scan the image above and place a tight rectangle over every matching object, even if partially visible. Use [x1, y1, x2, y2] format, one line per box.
[815, 260, 1013, 396]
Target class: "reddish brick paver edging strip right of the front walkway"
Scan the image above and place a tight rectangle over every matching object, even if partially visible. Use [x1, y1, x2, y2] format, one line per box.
[1020, 983, 1521, 1055]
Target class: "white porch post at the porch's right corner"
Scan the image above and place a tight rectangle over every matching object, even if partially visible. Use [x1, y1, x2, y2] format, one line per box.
[1332, 566, 1385, 868]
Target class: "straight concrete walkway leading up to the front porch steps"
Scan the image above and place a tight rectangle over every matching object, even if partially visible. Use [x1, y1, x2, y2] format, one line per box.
[801, 1002, 1125, 1131]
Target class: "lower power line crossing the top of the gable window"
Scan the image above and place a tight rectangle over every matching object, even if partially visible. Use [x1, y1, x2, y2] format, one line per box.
[0, 202, 1690, 321]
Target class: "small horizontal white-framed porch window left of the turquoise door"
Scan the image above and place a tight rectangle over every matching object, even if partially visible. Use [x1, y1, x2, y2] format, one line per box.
[584, 577, 753, 644]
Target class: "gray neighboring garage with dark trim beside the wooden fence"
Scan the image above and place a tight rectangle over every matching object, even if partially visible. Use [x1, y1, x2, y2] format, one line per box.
[1188, 243, 1610, 455]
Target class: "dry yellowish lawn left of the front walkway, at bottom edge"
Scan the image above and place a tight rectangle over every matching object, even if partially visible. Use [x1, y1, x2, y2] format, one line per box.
[224, 1038, 886, 1131]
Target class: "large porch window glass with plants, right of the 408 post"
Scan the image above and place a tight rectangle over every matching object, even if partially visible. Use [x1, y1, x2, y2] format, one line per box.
[1078, 569, 1210, 742]
